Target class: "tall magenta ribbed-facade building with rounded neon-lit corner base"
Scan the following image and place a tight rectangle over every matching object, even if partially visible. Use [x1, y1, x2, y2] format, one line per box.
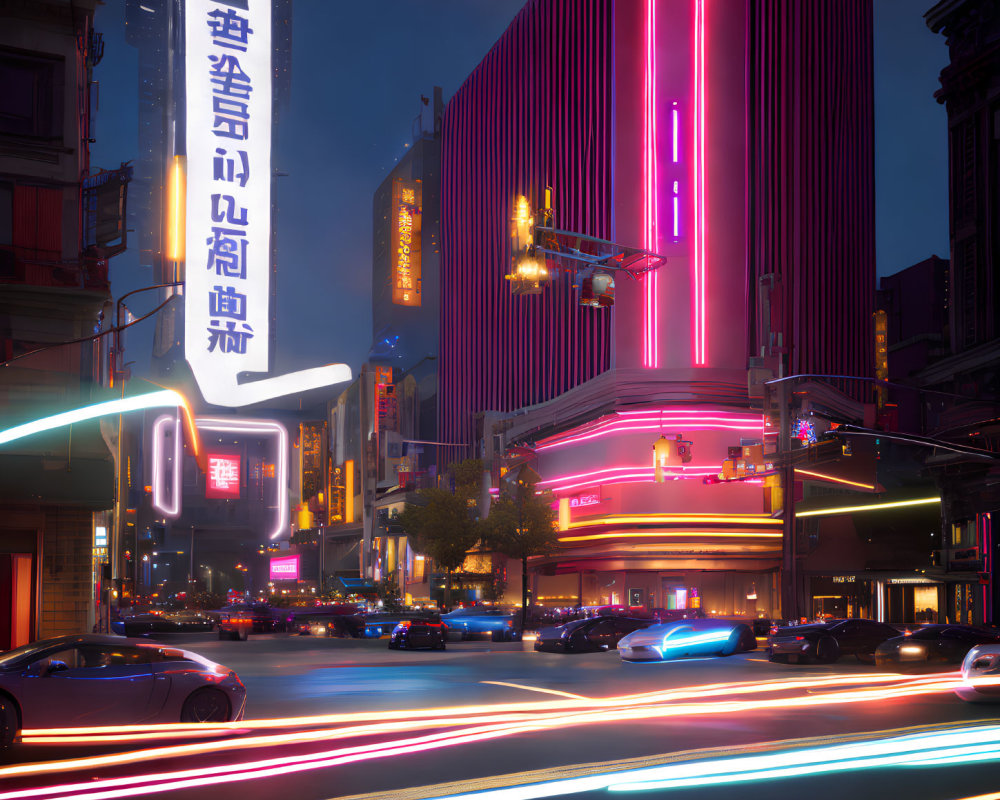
[439, 0, 874, 614]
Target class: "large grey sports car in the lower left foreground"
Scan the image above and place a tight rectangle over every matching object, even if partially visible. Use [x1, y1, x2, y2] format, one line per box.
[0, 634, 246, 747]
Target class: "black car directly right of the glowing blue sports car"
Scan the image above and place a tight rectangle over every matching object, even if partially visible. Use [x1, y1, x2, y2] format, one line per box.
[767, 619, 899, 664]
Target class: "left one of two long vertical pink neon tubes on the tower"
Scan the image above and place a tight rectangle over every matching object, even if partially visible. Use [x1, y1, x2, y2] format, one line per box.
[642, 0, 660, 369]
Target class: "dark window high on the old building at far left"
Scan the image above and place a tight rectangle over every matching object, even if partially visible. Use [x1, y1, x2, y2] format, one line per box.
[0, 50, 65, 139]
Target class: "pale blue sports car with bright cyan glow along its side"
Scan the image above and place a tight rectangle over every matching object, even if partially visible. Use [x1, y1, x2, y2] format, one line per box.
[618, 618, 757, 661]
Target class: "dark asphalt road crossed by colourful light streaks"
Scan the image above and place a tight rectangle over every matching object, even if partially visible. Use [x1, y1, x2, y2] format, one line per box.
[0, 634, 1000, 800]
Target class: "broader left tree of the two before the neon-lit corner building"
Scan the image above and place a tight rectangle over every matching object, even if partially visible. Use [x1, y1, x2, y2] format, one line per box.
[397, 459, 483, 607]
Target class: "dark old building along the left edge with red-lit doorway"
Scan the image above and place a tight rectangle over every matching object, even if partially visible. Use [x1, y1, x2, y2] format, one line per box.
[0, 0, 129, 650]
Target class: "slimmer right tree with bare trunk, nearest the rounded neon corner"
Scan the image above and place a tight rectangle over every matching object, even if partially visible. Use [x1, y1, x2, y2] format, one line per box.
[485, 465, 557, 629]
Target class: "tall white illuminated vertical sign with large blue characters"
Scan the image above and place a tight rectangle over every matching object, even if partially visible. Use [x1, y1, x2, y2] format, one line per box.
[184, 0, 271, 394]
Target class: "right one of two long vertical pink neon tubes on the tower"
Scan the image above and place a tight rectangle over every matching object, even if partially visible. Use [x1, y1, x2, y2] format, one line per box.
[692, 0, 706, 367]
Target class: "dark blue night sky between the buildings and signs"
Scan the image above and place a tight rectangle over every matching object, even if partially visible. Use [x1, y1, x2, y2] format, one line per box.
[91, 0, 948, 384]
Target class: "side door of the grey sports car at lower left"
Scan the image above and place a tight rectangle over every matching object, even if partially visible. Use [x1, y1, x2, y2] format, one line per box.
[21, 643, 153, 728]
